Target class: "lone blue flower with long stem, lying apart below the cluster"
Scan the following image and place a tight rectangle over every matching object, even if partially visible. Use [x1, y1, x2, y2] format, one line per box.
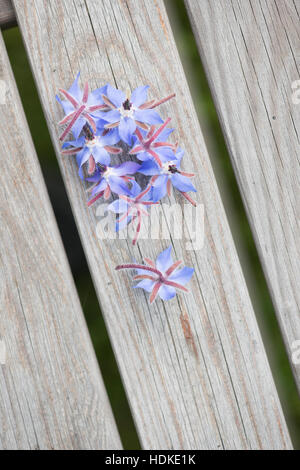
[115, 246, 194, 304]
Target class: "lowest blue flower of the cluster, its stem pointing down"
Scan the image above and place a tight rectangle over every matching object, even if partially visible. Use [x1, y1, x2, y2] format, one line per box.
[107, 181, 158, 245]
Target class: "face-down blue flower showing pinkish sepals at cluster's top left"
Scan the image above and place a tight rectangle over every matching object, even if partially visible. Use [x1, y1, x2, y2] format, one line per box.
[56, 72, 107, 140]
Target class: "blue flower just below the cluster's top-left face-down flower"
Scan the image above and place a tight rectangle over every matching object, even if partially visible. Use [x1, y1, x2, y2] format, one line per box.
[62, 128, 122, 177]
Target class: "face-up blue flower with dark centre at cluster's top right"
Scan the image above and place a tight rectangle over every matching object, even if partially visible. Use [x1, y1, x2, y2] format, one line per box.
[101, 85, 175, 145]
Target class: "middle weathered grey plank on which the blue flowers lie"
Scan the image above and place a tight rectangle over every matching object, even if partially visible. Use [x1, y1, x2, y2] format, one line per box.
[14, 0, 290, 449]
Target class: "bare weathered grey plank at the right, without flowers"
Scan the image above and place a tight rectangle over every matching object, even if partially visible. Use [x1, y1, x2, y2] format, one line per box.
[186, 0, 300, 390]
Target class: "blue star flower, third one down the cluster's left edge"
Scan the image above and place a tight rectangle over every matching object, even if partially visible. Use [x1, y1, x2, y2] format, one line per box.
[86, 162, 140, 206]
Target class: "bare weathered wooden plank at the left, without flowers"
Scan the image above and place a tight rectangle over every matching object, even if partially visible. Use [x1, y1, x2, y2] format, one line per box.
[0, 33, 121, 449]
